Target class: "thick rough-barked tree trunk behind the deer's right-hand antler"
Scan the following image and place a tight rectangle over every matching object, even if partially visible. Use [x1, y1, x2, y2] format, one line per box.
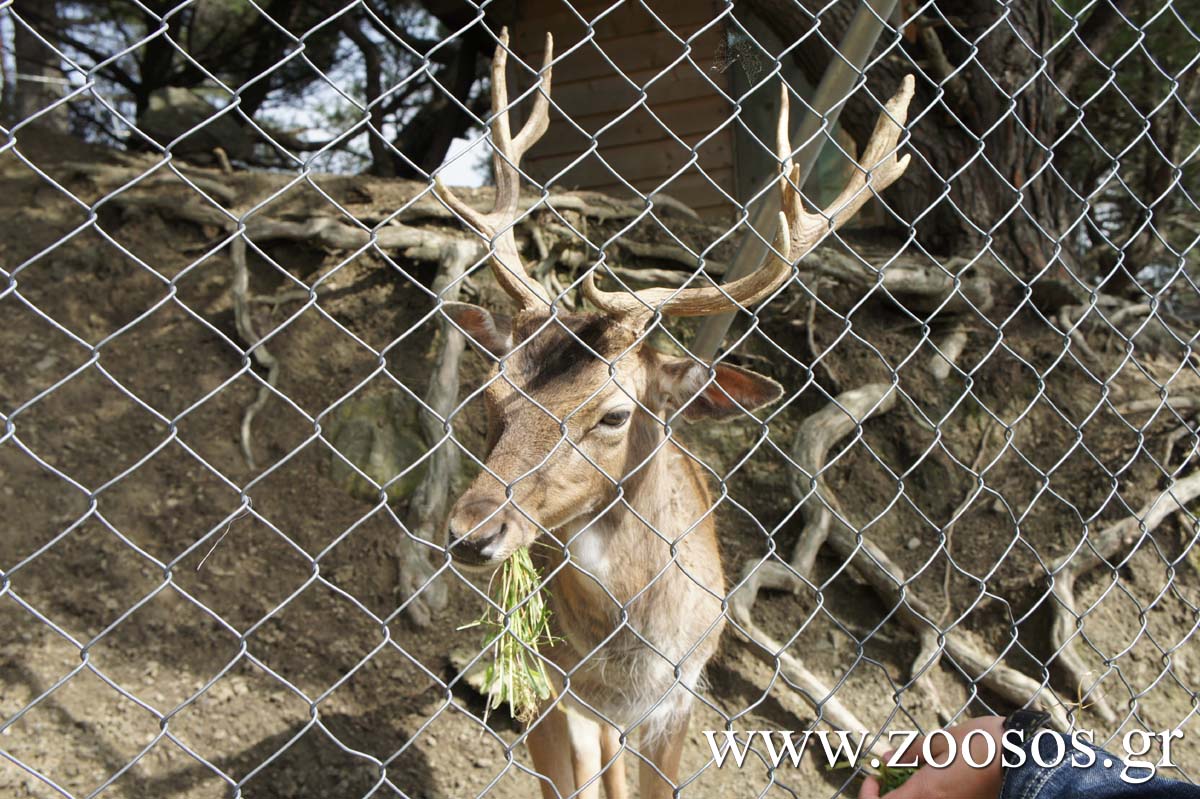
[748, 0, 1078, 277]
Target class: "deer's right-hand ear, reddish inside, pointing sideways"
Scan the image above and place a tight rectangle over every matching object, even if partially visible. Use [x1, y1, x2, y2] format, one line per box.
[659, 358, 784, 421]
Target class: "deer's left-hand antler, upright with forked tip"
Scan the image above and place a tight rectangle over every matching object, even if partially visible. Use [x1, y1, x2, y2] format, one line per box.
[436, 28, 554, 310]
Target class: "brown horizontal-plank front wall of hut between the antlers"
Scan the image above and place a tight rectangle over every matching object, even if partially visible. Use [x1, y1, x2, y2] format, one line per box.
[510, 0, 736, 218]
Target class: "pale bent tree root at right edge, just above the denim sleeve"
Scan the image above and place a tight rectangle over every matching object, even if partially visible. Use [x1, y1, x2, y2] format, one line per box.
[1050, 471, 1200, 722]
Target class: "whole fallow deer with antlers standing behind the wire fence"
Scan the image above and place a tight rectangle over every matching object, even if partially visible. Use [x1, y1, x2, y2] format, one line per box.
[438, 31, 913, 799]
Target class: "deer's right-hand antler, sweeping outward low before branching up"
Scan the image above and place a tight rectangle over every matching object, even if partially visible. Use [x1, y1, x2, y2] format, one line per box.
[583, 74, 914, 317]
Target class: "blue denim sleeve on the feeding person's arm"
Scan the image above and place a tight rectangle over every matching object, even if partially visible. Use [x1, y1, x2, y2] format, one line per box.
[1000, 734, 1200, 799]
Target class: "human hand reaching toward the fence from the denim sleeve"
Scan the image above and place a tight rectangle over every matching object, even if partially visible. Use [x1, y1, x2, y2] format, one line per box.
[858, 716, 1004, 799]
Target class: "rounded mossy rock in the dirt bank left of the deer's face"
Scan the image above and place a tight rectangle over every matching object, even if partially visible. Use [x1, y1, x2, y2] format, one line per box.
[326, 391, 430, 501]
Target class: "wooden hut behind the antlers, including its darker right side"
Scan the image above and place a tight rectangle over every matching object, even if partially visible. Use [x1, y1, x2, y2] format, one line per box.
[436, 0, 852, 221]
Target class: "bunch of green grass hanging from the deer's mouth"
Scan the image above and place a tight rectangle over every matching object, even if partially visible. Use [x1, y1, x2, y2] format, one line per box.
[463, 547, 554, 723]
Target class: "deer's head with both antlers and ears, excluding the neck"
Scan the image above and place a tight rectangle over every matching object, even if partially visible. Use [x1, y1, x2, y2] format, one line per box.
[438, 31, 913, 567]
